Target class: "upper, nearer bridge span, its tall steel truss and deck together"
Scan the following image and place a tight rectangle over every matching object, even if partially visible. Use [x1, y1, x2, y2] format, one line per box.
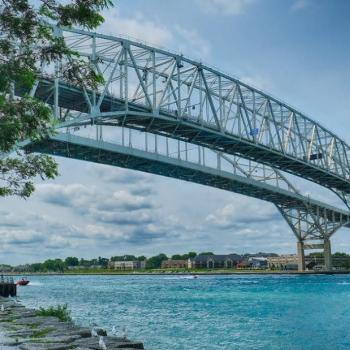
[24, 29, 350, 200]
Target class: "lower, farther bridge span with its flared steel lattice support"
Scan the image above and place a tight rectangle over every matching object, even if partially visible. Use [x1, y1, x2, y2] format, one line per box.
[25, 131, 350, 240]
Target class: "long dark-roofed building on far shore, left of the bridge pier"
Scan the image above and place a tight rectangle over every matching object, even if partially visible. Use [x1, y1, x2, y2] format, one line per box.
[189, 254, 242, 269]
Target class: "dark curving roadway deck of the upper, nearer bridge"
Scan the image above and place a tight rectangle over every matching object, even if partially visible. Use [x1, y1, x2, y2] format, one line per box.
[28, 80, 350, 194]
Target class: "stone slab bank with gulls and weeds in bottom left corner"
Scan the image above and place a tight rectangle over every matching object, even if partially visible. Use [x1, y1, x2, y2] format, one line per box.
[0, 298, 144, 350]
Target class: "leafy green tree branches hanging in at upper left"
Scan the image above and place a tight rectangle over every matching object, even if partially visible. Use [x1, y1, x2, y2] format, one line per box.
[0, 0, 112, 198]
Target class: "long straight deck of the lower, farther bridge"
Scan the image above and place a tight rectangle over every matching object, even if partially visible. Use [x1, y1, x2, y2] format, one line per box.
[25, 134, 350, 226]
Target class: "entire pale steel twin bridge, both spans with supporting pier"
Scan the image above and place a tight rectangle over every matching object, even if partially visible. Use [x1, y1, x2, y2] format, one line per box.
[16, 27, 350, 270]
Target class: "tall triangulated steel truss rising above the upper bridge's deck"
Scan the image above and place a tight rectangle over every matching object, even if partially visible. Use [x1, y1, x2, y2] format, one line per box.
[50, 29, 350, 187]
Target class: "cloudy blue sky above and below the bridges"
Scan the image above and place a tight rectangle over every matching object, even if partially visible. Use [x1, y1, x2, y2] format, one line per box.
[0, 0, 350, 265]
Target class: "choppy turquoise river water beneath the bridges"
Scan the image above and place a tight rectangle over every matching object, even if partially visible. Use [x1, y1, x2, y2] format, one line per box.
[15, 275, 350, 350]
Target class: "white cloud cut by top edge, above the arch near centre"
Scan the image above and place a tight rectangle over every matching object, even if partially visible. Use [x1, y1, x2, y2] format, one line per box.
[196, 0, 255, 15]
